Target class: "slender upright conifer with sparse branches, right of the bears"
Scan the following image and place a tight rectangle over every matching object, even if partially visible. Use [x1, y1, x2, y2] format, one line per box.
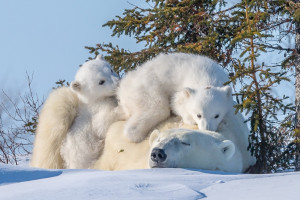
[227, 1, 295, 173]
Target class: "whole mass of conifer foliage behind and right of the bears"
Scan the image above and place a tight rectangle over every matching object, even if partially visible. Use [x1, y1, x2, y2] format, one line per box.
[86, 0, 300, 173]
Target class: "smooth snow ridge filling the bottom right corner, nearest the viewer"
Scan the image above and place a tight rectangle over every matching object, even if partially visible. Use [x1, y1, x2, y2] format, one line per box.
[202, 173, 300, 200]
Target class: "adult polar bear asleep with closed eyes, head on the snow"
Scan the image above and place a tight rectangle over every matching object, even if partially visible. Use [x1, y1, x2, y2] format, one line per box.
[92, 117, 255, 172]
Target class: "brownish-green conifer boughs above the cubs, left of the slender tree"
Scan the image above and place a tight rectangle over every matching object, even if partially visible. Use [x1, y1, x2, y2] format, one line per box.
[86, 0, 234, 72]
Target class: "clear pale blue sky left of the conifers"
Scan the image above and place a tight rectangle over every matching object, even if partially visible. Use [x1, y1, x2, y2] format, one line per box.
[0, 0, 145, 98]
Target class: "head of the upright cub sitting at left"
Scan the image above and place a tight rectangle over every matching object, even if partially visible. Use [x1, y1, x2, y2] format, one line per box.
[71, 56, 120, 102]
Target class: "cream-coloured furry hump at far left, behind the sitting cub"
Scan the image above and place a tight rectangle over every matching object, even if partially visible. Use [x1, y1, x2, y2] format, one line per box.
[30, 87, 78, 169]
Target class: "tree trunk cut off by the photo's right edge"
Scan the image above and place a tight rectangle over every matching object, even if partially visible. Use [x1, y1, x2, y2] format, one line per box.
[295, 19, 300, 171]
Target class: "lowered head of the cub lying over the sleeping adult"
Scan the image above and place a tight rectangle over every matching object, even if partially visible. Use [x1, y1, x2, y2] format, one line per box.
[172, 86, 233, 131]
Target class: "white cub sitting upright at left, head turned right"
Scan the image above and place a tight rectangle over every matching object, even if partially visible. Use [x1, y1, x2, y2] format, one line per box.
[61, 56, 119, 169]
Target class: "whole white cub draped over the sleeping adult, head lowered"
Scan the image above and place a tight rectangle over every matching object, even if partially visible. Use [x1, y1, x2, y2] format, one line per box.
[117, 53, 233, 142]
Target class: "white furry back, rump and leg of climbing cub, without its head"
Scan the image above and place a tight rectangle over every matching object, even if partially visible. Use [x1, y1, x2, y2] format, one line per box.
[117, 53, 228, 142]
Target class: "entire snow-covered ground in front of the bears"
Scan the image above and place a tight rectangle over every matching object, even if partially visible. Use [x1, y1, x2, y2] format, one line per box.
[0, 164, 300, 200]
